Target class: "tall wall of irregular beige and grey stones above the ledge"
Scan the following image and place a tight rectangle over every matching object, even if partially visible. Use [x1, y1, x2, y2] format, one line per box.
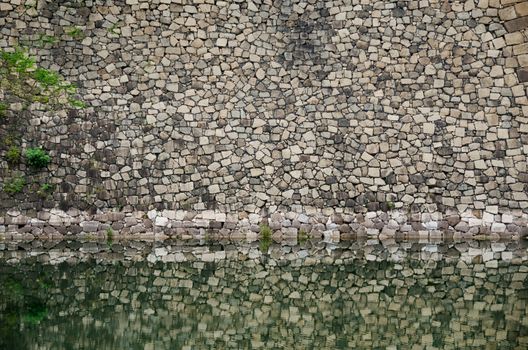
[0, 0, 528, 237]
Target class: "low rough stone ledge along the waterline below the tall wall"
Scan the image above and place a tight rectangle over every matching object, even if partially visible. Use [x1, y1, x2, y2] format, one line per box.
[0, 208, 528, 240]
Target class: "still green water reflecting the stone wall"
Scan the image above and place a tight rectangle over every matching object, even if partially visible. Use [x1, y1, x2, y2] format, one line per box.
[0, 241, 528, 350]
